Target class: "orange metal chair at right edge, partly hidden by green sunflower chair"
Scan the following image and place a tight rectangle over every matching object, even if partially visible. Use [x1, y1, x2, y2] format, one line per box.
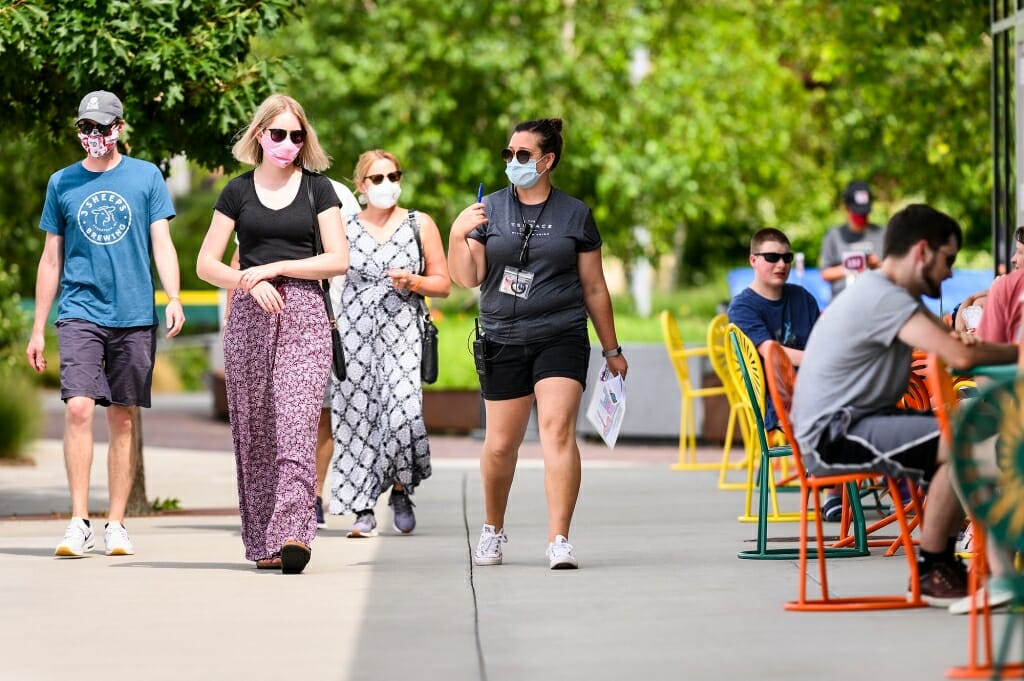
[924, 352, 1024, 679]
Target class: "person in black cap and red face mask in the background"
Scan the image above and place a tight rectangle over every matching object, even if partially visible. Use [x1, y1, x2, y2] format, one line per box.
[818, 180, 883, 298]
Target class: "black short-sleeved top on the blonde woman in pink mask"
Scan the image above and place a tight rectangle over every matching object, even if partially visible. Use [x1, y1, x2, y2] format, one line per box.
[214, 170, 341, 269]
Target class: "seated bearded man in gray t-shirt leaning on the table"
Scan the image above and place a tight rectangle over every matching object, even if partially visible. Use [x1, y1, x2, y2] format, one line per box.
[791, 204, 1017, 605]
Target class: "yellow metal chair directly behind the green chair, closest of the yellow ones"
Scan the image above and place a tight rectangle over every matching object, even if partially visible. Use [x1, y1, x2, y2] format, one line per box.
[726, 324, 800, 522]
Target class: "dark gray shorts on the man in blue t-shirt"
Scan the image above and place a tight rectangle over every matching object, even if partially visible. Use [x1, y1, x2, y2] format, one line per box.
[56, 320, 157, 407]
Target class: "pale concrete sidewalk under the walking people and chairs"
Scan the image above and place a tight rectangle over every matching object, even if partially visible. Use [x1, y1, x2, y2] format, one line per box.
[0, 438, 1007, 681]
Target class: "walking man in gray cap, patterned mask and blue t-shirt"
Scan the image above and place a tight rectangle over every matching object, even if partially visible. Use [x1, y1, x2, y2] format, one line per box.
[26, 90, 185, 558]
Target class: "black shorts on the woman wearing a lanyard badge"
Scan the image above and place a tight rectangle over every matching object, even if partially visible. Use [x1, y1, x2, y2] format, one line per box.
[480, 331, 590, 399]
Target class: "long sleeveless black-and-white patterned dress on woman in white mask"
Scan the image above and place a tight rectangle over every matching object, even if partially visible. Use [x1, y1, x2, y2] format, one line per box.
[328, 211, 430, 515]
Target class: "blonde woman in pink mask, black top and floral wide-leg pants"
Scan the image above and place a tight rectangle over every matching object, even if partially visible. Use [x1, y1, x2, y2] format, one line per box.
[196, 94, 348, 573]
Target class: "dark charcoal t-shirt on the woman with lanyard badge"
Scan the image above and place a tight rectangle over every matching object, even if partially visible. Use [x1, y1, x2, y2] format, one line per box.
[469, 187, 601, 344]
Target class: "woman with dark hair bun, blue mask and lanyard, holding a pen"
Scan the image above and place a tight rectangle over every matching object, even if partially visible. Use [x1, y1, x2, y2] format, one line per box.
[449, 118, 627, 569]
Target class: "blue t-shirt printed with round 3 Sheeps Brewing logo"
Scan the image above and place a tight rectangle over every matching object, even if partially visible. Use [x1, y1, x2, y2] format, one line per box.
[39, 156, 174, 328]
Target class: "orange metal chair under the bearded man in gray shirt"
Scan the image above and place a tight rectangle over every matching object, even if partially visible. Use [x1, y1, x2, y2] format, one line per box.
[765, 342, 926, 611]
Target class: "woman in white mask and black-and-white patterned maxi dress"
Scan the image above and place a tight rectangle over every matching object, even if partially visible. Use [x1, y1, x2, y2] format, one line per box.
[328, 150, 451, 538]
